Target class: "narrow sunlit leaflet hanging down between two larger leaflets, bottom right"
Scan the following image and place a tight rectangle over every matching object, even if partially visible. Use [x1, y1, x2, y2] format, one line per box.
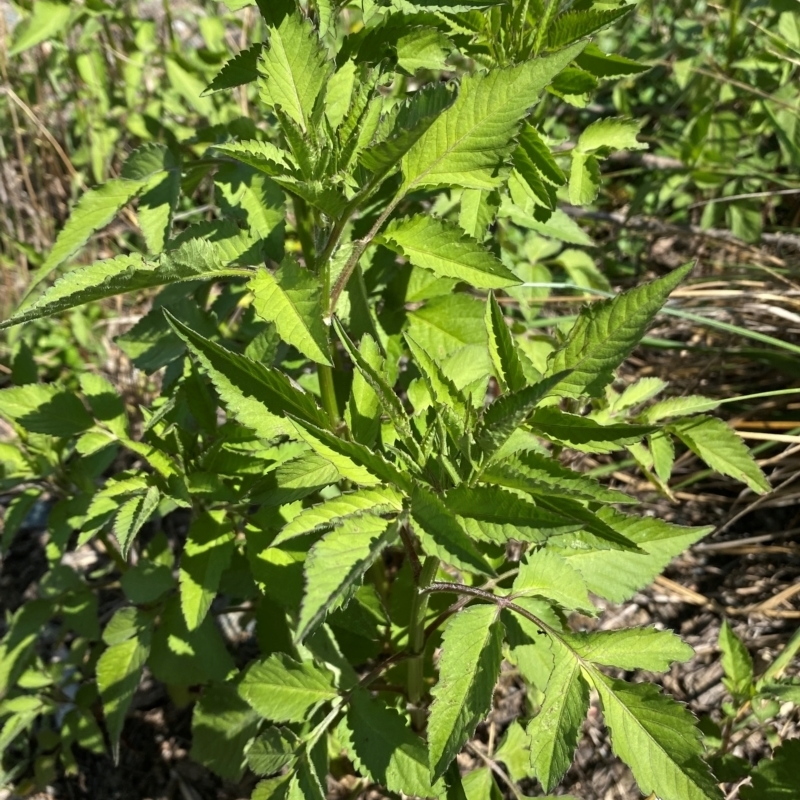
[527, 639, 589, 792]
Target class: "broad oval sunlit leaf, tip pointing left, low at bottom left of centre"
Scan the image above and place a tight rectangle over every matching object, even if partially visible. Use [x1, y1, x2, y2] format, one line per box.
[239, 653, 338, 722]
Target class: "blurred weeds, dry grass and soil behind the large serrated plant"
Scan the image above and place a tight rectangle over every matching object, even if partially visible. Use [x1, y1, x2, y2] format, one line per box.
[0, 0, 800, 800]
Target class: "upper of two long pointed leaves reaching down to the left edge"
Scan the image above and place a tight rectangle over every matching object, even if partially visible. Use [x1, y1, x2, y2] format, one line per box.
[18, 178, 145, 300]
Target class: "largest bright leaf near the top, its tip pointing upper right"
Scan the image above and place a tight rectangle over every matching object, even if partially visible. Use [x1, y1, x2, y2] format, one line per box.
[402, 44, 584, 192]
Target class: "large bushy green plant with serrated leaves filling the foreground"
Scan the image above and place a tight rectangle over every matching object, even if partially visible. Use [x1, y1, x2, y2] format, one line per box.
[0, 0, 788, 800]
